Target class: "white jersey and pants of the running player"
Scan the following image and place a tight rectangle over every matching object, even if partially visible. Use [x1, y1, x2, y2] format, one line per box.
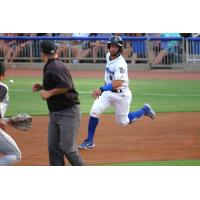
[90, 53, 132, 126]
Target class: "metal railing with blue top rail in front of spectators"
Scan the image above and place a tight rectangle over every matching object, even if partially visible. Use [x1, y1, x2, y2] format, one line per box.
[0, 36, 200, 67]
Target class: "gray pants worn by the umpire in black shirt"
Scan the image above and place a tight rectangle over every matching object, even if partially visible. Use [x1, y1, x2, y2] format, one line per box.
[48, 105, 84, 166]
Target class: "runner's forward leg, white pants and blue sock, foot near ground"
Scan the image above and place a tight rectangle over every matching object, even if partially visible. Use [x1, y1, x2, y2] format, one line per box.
[78, 91, 111, 149]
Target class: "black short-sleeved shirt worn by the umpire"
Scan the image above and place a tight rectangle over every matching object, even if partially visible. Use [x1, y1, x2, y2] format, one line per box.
[43, 59, 80, 112]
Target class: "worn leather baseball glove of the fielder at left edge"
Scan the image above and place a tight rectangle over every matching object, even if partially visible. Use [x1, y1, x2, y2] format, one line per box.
[9, 113, 32, 131]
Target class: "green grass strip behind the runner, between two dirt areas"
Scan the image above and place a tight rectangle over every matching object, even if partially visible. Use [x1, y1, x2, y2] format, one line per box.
[5, 77, 200, 116]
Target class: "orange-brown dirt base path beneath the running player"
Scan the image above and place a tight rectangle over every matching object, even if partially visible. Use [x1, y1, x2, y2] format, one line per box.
[5, 113, 200, 166]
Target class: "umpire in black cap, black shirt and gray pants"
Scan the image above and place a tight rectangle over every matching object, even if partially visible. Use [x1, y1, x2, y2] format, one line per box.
[32, 41, 84, 166]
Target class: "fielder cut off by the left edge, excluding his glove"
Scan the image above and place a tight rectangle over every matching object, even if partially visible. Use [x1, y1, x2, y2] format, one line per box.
[0, 63, 21, 166]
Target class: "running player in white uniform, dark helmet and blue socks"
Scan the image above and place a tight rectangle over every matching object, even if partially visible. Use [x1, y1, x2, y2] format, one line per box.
[78, 36, 156, 149]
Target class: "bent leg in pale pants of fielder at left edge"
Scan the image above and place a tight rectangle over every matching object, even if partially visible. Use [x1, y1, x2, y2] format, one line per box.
[0, 129, 21, 166]
